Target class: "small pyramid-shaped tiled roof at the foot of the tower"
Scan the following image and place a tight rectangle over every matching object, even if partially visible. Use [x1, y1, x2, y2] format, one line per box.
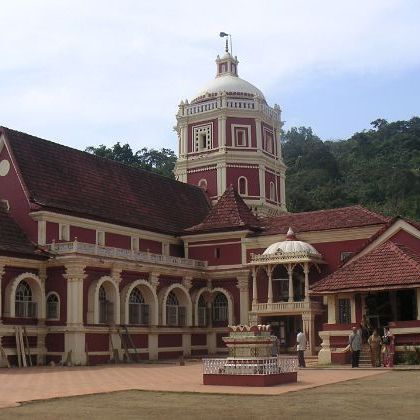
[186, 185, 260, 234]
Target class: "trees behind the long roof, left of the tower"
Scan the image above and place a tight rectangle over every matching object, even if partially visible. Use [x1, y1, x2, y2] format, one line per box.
[85, 142, 176, 178]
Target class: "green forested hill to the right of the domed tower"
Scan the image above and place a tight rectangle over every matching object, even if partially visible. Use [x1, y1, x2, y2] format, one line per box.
[283, 117, 420, 219]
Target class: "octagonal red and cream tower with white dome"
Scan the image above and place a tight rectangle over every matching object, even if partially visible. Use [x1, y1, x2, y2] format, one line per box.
[174, 41, 286, 215]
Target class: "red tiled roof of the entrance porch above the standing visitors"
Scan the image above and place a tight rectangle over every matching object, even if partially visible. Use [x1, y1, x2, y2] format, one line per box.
[311, 241, 420, 294]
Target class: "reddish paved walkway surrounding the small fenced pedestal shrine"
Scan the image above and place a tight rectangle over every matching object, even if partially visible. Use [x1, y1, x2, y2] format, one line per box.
[0, 363, 385, 408]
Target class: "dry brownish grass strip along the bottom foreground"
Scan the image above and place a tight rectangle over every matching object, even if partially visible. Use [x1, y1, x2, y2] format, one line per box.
[0, 371, 420, 420]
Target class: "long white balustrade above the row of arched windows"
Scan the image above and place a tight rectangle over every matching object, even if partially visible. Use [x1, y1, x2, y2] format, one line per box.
[49, 240, 207, 270]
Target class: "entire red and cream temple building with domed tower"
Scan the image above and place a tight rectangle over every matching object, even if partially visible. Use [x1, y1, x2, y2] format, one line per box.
[0, 43, 420, 365]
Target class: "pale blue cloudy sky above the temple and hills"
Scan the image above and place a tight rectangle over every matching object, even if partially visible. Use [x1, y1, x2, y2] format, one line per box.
[0, 0, 420, 151]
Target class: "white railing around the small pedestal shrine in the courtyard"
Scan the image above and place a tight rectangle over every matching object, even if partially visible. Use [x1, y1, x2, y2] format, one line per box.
[203, 357, 298, 375]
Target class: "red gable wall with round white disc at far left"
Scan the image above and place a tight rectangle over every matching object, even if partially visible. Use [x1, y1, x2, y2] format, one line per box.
[0, 147, 38, 242]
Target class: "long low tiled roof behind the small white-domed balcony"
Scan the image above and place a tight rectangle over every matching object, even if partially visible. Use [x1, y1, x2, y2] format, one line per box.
[263, 206, 389, 235]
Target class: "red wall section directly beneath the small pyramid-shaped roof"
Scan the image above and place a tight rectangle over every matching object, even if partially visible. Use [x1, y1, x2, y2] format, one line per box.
[188, 243, 242, 266]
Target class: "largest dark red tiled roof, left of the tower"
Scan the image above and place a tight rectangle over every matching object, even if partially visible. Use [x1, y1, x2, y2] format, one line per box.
[0, 127, 210, 234]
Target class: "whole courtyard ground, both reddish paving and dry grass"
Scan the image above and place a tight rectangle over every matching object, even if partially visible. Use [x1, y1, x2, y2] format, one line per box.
[0, 363, 420, 420]
